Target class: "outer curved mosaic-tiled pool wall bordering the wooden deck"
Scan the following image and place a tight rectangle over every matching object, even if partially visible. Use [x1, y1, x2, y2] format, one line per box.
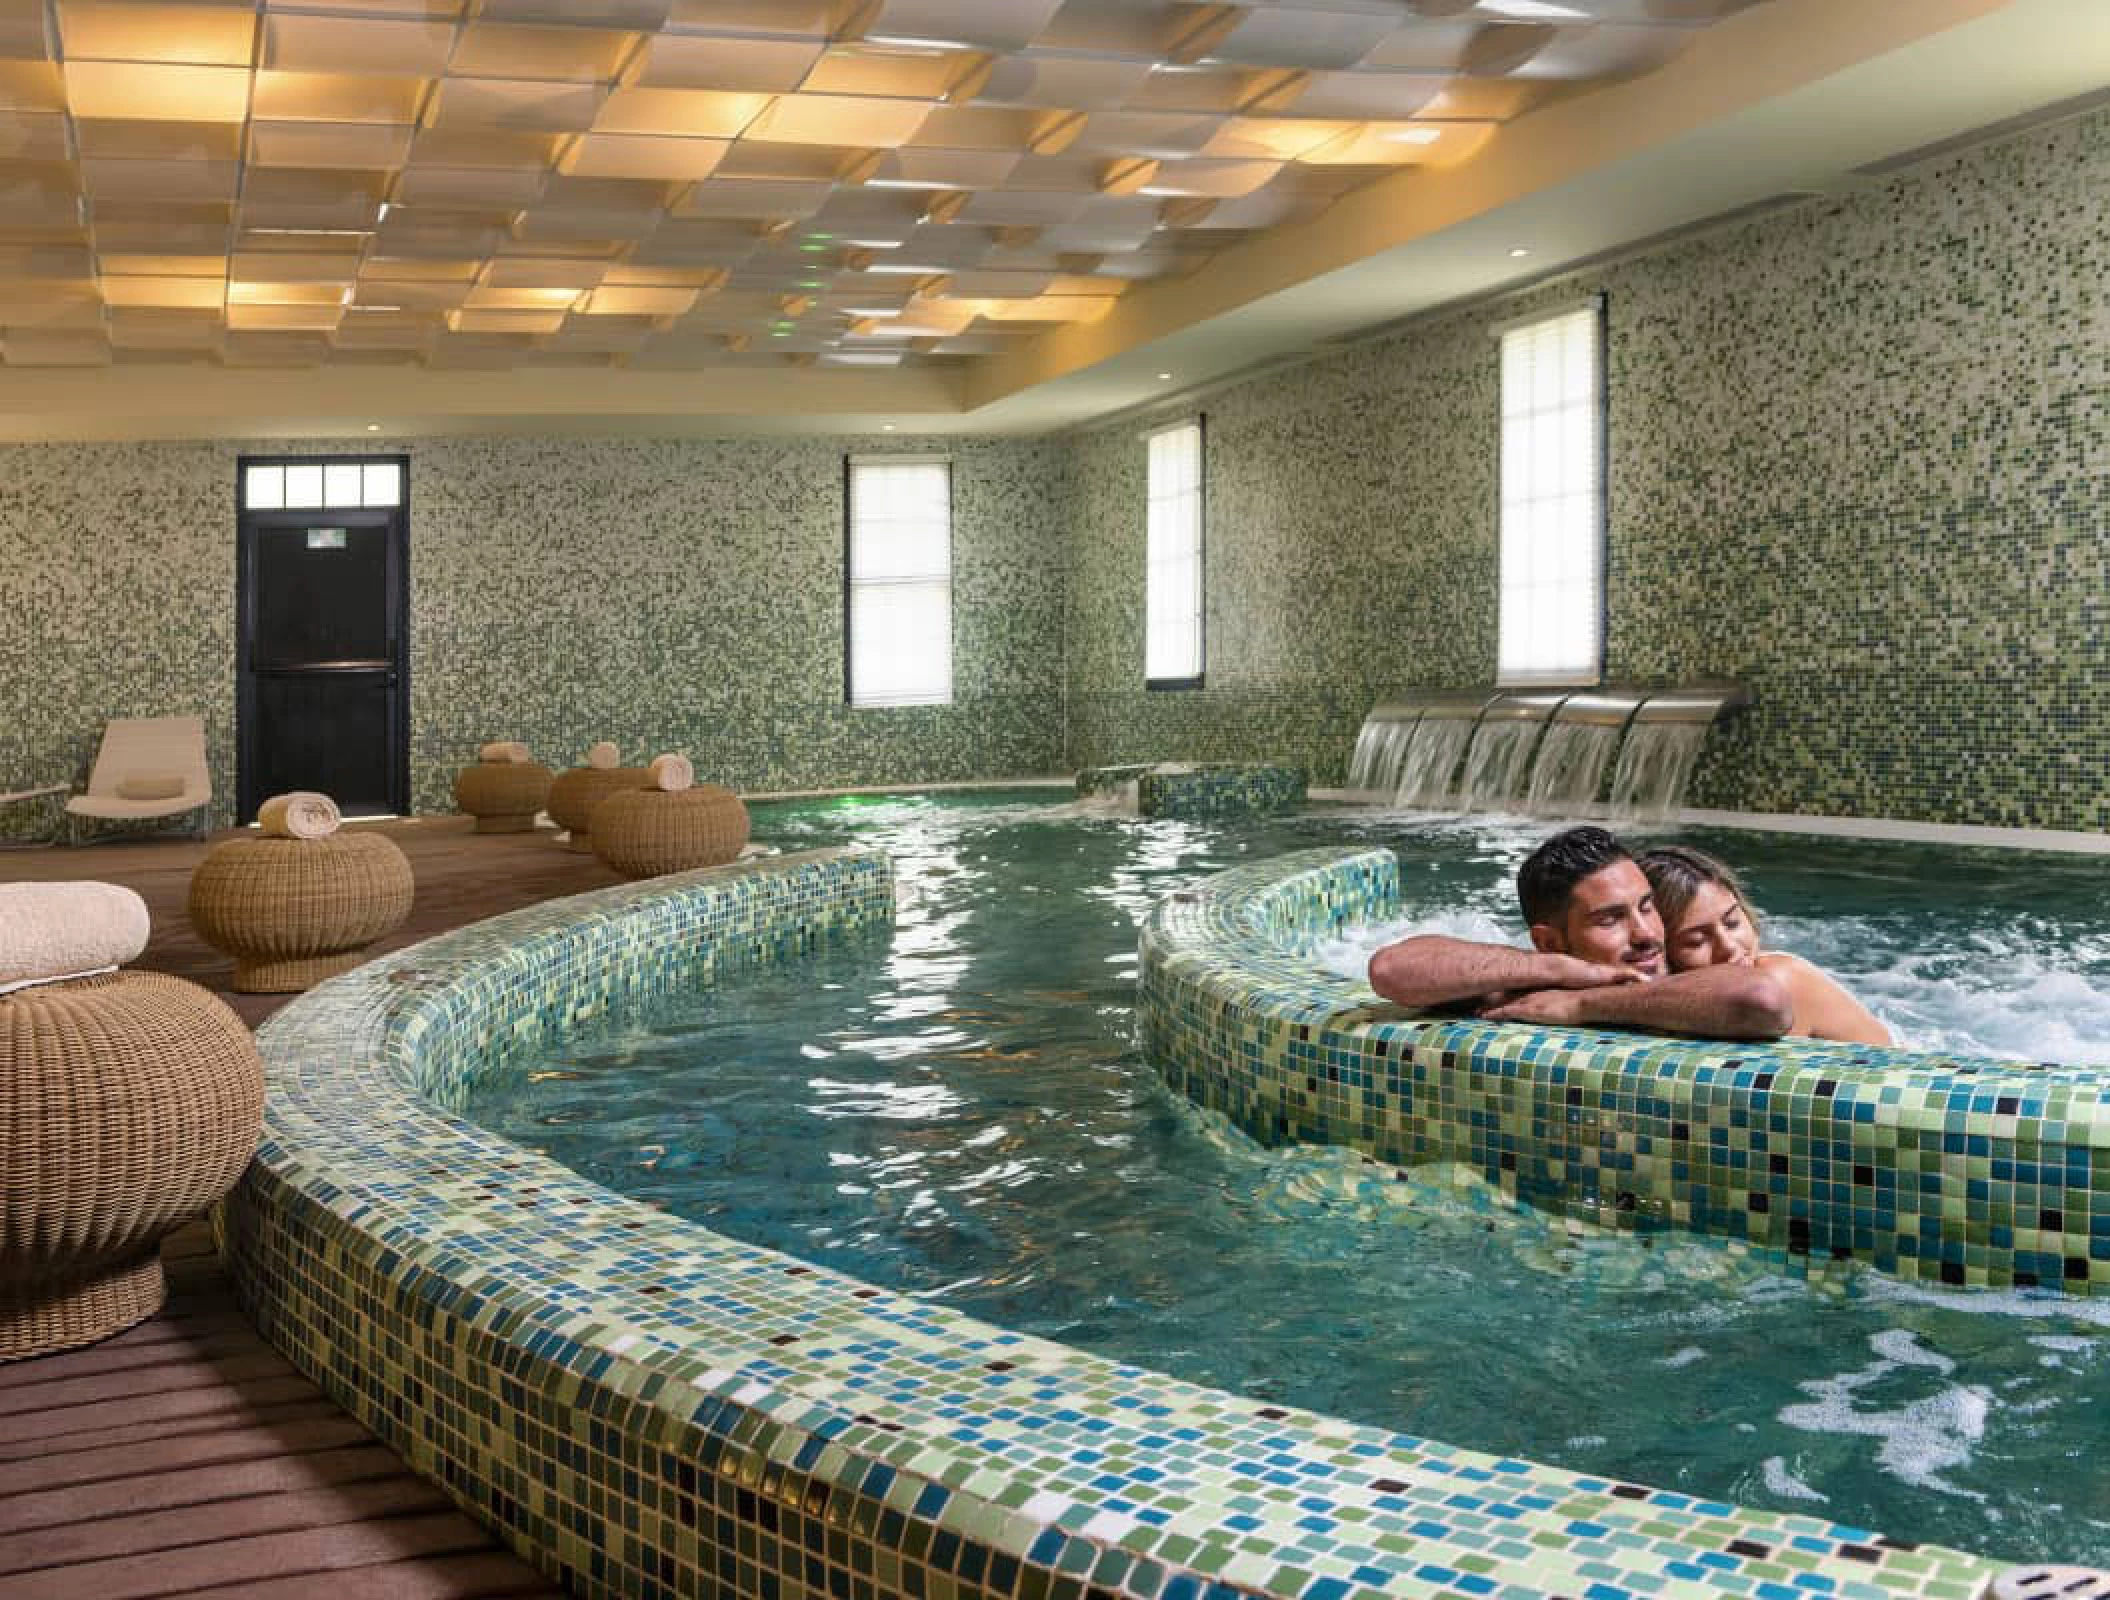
[224, 851, 1990, 1600]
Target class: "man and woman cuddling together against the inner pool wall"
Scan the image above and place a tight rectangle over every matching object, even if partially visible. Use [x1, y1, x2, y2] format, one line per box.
[1369, 827, 1891, 1045]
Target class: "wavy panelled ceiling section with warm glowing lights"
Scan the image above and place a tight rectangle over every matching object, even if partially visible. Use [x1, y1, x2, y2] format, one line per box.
[0, 0, 1763, 374]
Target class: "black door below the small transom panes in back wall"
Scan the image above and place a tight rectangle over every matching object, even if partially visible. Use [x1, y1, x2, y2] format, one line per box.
[238, 489, 409, 817]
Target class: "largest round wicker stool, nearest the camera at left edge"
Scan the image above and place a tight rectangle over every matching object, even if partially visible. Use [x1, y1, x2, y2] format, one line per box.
[0, 973, 264, 1361]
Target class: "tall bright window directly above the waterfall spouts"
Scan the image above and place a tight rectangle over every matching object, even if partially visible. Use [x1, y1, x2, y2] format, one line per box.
[1496, 302, 1604, 684]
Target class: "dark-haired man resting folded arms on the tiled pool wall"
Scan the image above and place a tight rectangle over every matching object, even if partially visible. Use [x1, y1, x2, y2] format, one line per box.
[1369, 827, 1794, 1039]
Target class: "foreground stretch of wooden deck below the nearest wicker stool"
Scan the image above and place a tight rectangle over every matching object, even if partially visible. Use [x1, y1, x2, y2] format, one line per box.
[0, 1224, 561, 1600]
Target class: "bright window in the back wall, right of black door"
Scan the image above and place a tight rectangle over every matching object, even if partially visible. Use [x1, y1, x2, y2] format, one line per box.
[848, 456, 952, 705]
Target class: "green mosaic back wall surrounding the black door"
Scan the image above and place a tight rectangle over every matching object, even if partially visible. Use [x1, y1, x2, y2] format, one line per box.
[0, 439, 1068, 827]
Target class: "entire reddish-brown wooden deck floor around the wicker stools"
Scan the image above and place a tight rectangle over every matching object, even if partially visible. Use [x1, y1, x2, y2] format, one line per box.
[0, 819, 616, 1600]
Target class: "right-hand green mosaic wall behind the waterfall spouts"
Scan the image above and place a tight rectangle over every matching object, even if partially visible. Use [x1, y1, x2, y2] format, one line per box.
[1063, 114, 2110, 830]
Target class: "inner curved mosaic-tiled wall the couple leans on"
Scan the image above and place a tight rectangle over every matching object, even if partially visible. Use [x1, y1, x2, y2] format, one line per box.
[1137, 849, 2110, 1294]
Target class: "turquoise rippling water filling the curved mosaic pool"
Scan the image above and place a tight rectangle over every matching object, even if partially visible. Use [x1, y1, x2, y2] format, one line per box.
[471, 792, 2110, 1562]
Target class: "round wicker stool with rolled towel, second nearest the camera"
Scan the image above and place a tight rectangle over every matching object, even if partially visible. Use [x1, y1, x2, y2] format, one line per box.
[190, 834, 411, 994]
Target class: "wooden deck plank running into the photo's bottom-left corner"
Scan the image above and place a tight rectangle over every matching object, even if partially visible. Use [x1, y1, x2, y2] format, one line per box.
[0, 1511, 490, 1600]
